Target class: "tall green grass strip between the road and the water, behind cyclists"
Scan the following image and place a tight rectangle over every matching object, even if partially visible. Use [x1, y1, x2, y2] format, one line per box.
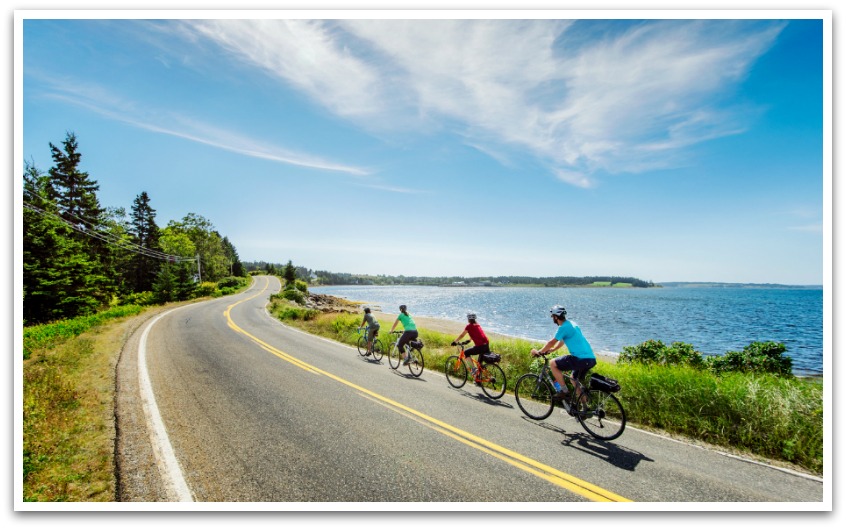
[270, 301, 823, 475]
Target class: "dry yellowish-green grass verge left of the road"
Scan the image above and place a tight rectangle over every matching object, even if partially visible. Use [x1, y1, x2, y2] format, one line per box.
[23, 314, 144, 501]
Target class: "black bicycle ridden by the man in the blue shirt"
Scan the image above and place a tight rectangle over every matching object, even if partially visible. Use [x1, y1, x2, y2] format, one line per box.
[514, 355, 626, 441]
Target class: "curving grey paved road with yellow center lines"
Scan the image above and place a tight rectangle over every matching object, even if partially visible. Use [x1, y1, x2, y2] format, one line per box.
[118, 277, 823, 502]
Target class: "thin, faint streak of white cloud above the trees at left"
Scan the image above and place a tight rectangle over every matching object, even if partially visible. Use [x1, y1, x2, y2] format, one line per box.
[33, 73, 370, 176]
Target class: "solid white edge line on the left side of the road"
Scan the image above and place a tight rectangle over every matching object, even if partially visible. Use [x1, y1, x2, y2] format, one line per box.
[138, 307, 194, 502]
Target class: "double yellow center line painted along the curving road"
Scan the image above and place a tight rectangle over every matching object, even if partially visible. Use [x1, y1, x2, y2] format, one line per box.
[224, 278, 631, 502]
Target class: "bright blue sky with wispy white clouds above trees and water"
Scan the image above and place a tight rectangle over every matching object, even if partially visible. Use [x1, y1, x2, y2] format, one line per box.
[18, 11, 830, 284]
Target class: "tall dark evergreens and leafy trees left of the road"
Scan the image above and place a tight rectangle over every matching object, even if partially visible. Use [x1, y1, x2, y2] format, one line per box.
[23, 132, 246, 324]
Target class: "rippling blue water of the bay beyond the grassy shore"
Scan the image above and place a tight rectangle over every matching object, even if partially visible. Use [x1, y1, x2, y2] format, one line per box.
[311, 286, 823, 375]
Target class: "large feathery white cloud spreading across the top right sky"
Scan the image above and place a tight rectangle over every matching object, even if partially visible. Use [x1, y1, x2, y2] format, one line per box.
[180, 20, 784, 186]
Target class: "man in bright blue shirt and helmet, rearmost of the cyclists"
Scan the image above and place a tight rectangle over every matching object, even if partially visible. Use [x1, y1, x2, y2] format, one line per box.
[532, 305, 596, 401]
